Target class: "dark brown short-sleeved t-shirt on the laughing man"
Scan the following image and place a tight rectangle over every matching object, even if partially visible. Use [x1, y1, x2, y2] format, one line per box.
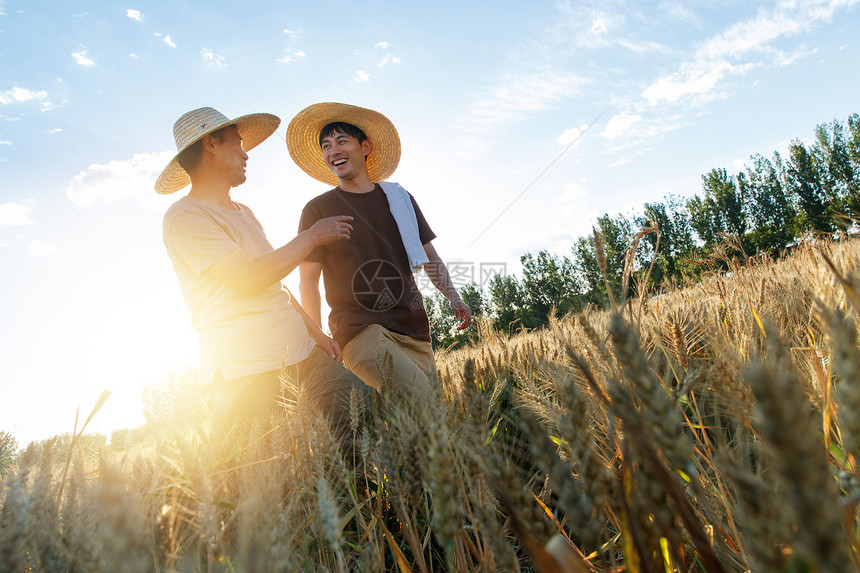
[299, 185, 436, 346]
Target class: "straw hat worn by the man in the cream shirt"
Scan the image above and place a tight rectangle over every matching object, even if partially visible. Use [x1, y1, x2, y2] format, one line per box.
[155, 107, 281, 195]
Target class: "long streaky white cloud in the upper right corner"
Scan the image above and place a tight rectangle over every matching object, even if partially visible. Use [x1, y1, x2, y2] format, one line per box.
[642, 0, 860, 103]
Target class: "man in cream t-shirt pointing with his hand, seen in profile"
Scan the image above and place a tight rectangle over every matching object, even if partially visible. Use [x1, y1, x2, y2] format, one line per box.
[155, 108, 372, 433]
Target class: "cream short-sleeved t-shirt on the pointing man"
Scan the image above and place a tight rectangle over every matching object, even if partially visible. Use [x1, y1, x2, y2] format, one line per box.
[162, 196, 315, 383]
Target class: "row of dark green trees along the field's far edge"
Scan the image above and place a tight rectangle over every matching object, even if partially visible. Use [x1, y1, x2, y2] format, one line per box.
[425, 109, 860, 348]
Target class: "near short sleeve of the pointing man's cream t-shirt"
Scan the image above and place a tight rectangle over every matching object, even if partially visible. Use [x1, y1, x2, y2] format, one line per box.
[164, 211, 241, 275]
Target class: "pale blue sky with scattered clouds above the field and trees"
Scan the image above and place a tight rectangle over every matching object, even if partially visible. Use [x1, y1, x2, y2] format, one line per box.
[0, 0, 860, 443]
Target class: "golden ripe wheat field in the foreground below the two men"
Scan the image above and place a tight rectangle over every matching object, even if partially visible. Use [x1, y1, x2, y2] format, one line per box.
[0, 241, 860, 573]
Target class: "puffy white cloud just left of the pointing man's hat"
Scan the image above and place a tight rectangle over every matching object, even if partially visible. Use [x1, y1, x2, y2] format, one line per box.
[65, 151, 175, 208]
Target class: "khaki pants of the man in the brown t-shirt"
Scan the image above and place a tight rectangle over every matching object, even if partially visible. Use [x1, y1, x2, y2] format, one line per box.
[343, 324, 436, 400]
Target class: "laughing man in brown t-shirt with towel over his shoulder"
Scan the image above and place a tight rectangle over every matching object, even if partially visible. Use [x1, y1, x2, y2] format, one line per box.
[287, 103, 472, 398]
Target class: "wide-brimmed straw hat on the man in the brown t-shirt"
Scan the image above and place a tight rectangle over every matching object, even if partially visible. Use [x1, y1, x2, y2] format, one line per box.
[287, 102, 400, 185]
